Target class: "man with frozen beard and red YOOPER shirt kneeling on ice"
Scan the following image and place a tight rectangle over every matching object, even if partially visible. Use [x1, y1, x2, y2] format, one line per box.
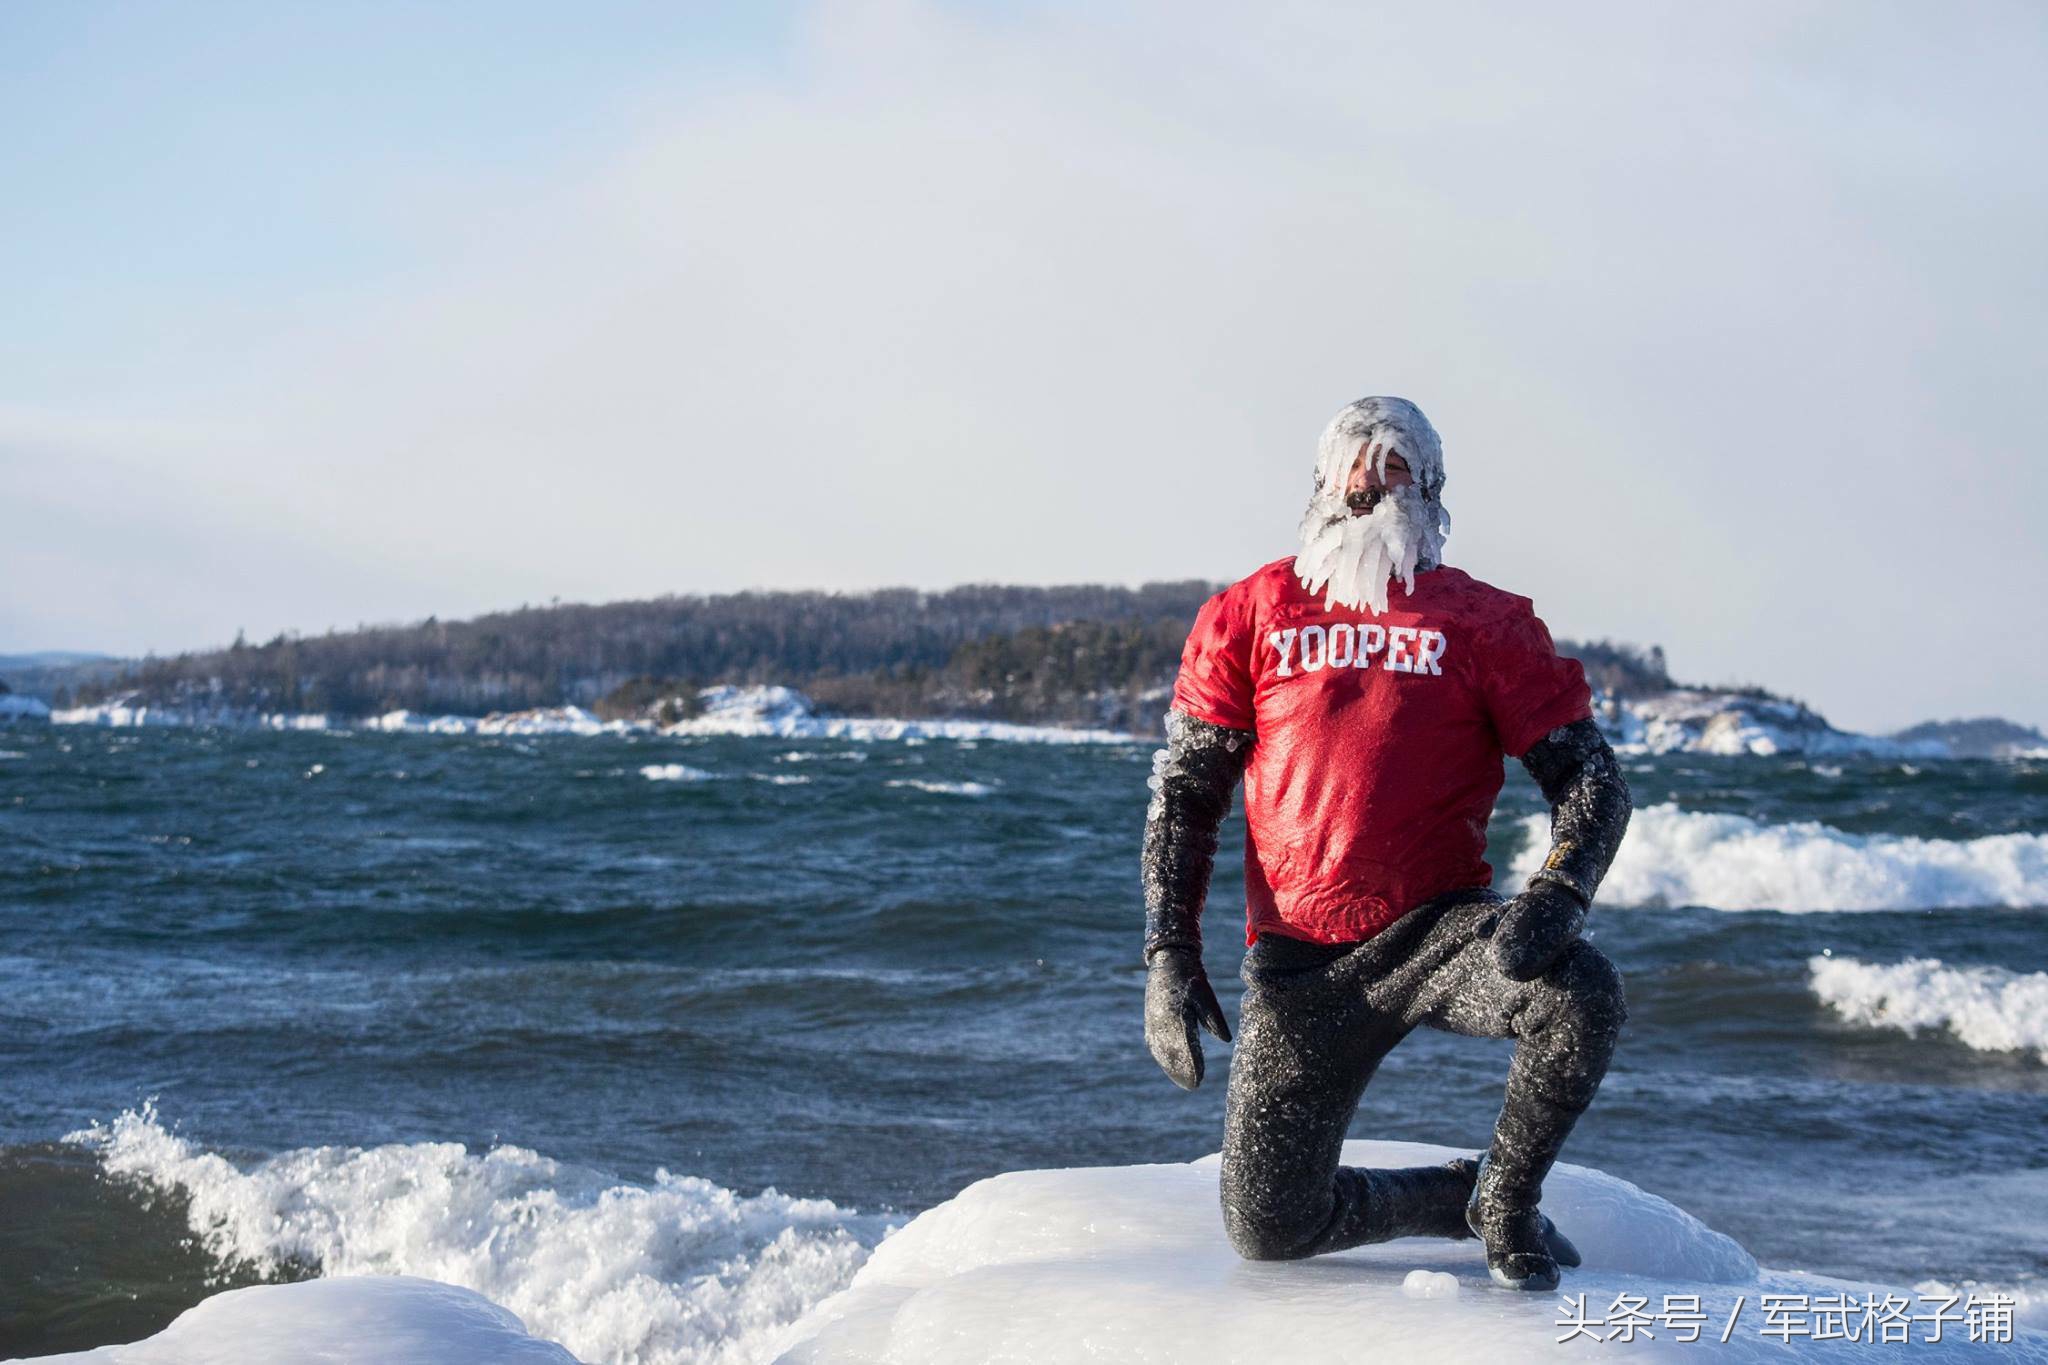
[1145, 397, 1630, 1289]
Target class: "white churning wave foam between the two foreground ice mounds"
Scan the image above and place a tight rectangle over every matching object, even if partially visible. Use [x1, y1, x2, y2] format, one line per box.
[68, 1107, 885, 1365]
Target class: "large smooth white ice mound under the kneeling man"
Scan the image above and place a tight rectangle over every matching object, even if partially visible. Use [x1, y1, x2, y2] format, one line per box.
[778, 1142, 2048, 1365]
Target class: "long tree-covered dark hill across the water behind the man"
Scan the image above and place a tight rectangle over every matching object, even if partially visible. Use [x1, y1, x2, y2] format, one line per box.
[64, 579, 1671, 731]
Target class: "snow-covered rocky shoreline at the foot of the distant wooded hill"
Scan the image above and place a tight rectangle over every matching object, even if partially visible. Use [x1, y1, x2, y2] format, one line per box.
[32, 684, 2048, 759]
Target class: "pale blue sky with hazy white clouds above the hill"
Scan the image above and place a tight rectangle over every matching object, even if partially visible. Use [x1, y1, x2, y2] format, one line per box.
[0, 0, 2048, 729]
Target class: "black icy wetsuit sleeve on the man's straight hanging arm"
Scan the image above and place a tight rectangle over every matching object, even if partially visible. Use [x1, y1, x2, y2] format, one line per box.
[1143, 710, 1253, 962]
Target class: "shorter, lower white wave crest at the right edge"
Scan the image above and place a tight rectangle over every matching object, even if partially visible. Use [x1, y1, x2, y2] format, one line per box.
[1806, 954, 2048, 1062]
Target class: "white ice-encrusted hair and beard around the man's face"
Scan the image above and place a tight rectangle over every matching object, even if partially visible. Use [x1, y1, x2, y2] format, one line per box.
[1294, 397, 1450, 612]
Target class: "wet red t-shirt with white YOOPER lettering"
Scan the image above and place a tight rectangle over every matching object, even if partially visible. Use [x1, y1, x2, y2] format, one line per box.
[1174, 557, 1593, 943]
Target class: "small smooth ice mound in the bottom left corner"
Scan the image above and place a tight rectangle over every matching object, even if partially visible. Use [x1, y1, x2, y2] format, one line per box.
[25, 1275, 575, 1365]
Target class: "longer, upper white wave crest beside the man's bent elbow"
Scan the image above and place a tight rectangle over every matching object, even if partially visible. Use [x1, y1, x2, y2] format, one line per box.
[1511, 802, 2048, 911]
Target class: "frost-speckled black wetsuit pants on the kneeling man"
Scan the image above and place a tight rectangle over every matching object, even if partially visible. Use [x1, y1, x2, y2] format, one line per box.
[1223, 890, 1626, 1261]
